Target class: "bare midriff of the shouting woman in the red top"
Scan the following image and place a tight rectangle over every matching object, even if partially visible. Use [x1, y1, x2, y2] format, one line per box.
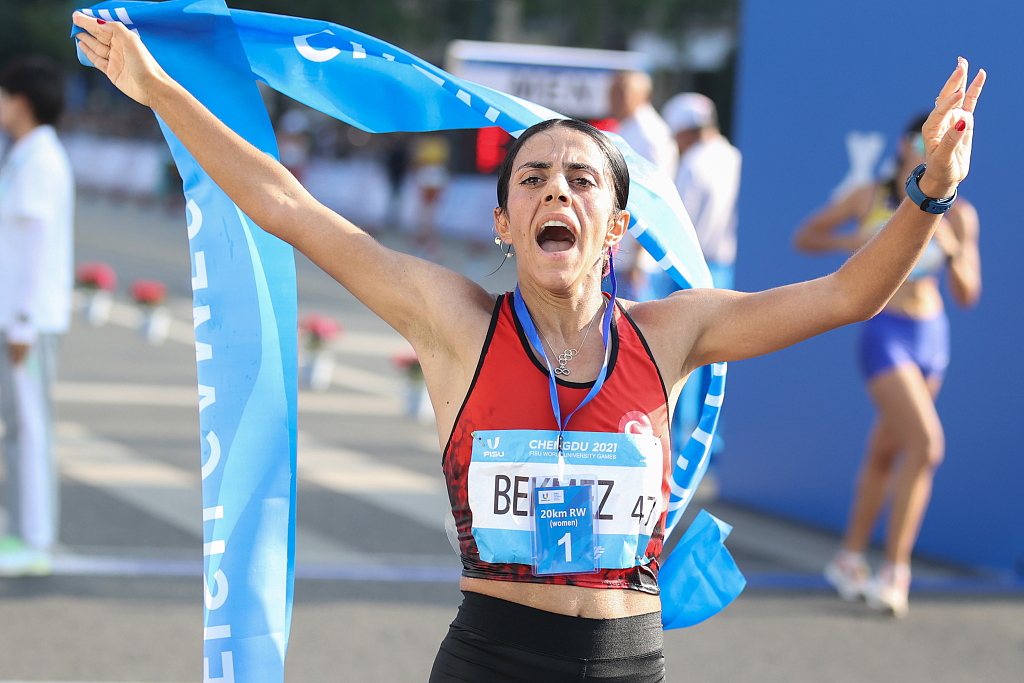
[459, 577, 662, 618]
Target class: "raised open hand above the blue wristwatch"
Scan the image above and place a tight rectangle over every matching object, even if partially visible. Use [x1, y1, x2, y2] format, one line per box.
[918, 57, 985, 199]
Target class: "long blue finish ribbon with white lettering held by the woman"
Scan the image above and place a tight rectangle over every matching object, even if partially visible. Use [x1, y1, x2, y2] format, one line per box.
[73, 0, 741, 683]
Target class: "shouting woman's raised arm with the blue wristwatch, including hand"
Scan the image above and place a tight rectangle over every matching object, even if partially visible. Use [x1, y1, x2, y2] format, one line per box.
[634, 58, 985, 380]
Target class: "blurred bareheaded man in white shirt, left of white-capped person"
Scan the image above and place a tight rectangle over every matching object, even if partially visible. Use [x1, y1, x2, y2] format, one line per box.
[608, 71, 679, 301]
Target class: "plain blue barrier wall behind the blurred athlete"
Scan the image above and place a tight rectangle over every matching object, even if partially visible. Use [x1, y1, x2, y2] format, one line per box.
[718, 0, 1024, 577]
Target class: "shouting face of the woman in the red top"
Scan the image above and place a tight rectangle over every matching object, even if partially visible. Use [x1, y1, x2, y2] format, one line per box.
[495, 127, 629, 292]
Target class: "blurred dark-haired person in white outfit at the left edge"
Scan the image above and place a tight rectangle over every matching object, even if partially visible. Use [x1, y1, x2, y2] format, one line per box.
[0, 56, 75, 577]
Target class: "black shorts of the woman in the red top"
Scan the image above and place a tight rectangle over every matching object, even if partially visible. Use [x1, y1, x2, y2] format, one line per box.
[430, 591, 665, 683]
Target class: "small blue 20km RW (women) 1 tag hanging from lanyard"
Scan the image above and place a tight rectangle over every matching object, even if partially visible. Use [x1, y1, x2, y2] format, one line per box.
[531, 483, 597, 577]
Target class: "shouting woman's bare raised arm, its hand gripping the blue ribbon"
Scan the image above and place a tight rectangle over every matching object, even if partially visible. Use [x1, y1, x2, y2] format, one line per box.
[74, 12, 494, 358]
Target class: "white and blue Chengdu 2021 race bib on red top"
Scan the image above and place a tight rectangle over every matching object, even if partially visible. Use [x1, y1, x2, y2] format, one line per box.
[468, 429, 664, 569]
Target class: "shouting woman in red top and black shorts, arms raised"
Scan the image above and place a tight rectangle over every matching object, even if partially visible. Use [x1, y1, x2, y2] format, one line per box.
[75, 13, 984, 681]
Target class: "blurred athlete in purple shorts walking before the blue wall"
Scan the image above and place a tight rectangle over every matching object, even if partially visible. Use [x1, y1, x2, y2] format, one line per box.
[794, 108, 981, 616]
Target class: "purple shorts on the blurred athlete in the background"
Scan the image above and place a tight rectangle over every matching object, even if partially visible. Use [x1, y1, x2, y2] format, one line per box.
[858, 311, 949, 380]
